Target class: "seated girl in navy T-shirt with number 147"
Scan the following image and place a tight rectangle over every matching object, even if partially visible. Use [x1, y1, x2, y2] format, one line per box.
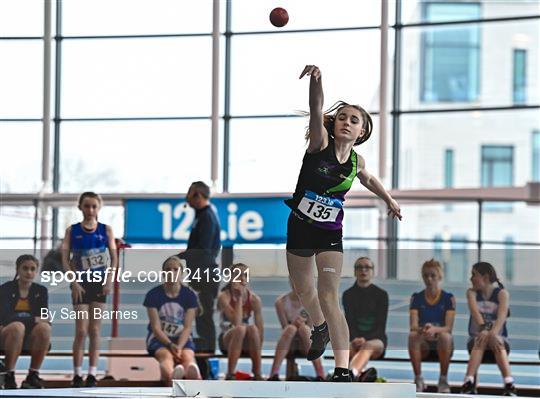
[144, 256, 201, 386]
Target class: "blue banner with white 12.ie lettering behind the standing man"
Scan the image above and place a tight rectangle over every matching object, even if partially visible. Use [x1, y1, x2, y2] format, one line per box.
[125, 197, 289, 246]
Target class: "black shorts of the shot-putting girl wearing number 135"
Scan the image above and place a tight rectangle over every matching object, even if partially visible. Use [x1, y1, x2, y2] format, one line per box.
[287, 211, 343, 257]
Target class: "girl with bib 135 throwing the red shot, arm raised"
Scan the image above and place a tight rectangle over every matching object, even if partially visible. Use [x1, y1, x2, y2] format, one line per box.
[285, 65, 401, 382]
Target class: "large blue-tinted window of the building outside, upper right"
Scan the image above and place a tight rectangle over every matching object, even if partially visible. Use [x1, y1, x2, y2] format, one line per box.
[420, 3, 480, 102]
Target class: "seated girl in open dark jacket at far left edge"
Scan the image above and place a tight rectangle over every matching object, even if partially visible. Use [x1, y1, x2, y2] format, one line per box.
[0, 255, 51, 389]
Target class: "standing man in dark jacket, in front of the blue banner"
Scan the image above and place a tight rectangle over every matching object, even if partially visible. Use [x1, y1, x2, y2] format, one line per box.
[178, 181, 221, 352]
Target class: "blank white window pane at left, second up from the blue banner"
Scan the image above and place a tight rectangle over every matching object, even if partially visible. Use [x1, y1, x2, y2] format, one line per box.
[61, 36, 212, 118]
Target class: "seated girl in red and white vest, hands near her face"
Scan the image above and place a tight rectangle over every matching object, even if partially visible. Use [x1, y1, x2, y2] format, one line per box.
[218, 263, 264, 380]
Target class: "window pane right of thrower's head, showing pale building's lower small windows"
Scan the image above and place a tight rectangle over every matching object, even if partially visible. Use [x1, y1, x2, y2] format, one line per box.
[398, 109, 540, 189]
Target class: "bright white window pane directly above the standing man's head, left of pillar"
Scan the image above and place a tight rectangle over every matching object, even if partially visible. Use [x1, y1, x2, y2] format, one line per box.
[60, 119, 210, 193]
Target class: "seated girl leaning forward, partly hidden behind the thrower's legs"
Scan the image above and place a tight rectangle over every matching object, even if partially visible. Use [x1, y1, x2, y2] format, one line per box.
[268, 291, 324, 381]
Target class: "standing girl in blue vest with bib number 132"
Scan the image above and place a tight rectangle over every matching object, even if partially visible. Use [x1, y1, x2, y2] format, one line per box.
[62, 191, 118, 388]
